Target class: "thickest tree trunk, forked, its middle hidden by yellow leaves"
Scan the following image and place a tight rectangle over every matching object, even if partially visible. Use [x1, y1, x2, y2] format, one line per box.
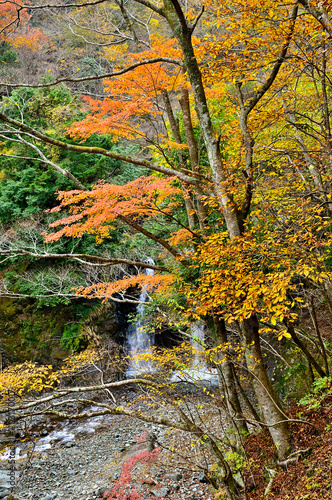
[162, 0, 297, 459]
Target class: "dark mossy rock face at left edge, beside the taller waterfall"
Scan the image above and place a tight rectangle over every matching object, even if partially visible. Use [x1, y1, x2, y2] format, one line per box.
[0, 298, 123, 368]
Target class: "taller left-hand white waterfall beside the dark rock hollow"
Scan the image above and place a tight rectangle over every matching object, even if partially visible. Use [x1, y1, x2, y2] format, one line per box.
[126, 258, 154, 378]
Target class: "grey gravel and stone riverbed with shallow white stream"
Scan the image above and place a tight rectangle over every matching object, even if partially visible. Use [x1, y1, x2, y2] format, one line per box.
[0, 394, 218, 500]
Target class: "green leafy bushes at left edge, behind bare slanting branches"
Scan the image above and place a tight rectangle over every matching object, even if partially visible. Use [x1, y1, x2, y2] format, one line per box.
[0, 86, 146, 223]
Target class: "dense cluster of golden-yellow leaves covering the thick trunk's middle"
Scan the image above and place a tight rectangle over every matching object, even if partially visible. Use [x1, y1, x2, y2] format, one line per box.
[190, 182, 330, 326]
